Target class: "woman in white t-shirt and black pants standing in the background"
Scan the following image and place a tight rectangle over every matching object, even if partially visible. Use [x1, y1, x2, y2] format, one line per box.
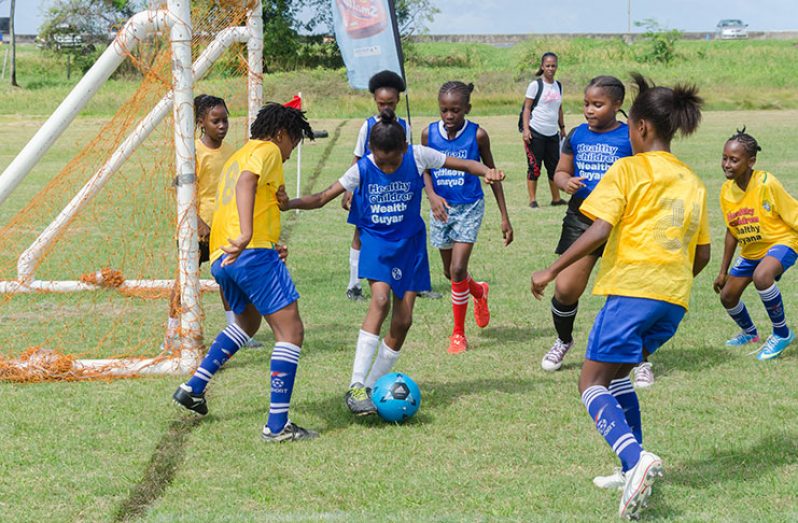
[521, 52, 566, 209]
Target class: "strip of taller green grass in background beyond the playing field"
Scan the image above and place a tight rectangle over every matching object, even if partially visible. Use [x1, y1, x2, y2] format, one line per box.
[0, 38, 798, 118]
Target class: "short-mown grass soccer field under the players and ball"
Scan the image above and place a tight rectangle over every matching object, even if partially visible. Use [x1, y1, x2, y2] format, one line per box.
[0, 108, 798, 522]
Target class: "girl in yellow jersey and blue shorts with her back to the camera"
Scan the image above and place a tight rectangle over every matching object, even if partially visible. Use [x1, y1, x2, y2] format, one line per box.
[532, 75, 710, 518]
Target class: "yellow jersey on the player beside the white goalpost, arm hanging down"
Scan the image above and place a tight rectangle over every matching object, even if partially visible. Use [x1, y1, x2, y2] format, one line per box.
[210, 140, 285, 263]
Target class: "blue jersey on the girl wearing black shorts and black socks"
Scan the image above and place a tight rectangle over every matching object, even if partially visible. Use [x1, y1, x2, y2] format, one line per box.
[563, 122, 632, 200]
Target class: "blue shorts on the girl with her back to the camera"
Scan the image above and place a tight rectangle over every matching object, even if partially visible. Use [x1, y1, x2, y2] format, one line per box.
[585, 296, 685, 363]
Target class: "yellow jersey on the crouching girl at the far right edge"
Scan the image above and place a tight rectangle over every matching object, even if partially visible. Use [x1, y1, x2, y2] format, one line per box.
[720, 171, 798, 260]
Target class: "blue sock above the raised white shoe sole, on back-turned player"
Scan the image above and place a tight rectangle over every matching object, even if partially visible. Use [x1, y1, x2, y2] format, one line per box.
[582, 385, 643, 472]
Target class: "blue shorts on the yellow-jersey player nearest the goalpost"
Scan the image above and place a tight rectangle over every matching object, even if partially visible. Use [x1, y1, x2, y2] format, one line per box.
[211, 249, 299, 316]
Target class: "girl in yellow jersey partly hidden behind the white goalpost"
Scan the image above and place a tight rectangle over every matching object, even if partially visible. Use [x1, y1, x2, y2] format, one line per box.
[162, 94, 263, 350]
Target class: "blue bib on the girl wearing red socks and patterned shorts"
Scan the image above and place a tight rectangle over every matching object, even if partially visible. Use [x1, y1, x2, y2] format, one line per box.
[427, 121, 484, 205]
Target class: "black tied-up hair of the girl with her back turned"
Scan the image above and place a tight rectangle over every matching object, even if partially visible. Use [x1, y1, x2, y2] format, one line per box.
[629, 73, 704, 142]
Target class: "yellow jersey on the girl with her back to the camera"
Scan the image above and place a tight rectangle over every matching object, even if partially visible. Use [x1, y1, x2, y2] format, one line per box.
[580, 151, 709, 309]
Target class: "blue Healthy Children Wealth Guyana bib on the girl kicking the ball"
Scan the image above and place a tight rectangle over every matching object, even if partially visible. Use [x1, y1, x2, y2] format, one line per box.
[352, 147, 426, 240]
